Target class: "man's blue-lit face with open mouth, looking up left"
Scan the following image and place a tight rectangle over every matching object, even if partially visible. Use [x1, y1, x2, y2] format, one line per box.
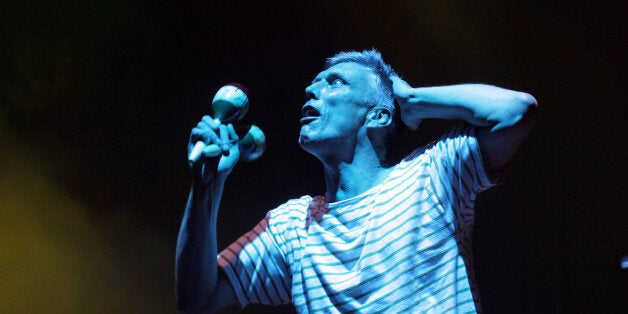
[299, 62, 375, 155]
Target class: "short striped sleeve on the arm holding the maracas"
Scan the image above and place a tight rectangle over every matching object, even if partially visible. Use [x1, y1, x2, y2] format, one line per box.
[218, 216, 290, 307]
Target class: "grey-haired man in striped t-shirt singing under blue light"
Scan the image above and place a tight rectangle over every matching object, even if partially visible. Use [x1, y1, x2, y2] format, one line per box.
[176, 50, 537, 313]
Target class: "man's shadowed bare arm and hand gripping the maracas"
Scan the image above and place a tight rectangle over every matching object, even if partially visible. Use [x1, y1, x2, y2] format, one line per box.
[175, 116, 240, 313]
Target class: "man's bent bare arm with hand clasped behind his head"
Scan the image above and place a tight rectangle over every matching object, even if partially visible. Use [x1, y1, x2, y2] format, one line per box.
[391, 77, 538, 177]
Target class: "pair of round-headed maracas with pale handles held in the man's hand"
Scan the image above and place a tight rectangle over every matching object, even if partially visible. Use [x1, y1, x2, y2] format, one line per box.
[188, 83, 266, 164]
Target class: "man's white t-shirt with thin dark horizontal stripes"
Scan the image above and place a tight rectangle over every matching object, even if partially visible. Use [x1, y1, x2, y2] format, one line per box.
[218, 125, 493, 313]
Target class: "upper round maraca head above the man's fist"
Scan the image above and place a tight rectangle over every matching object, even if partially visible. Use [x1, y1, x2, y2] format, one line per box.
[212, 83, 249, 124]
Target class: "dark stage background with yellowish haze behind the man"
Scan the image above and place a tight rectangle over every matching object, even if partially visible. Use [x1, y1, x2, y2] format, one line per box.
[0, 0, 628, 313]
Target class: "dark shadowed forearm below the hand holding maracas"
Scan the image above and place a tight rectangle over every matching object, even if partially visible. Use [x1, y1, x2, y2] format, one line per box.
[175, 181, 224, 311]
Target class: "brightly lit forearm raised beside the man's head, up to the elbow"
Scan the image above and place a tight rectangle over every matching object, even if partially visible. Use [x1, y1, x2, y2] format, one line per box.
[400, 84, 536, 131]
